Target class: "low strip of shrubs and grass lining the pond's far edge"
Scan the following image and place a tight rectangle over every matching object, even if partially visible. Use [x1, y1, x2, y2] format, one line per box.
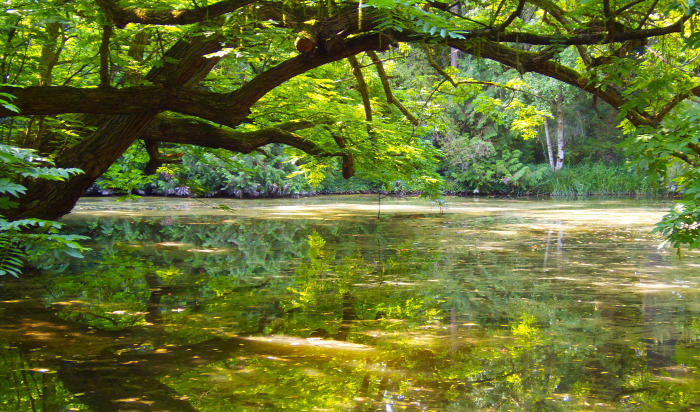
[85, 163, 680, 199]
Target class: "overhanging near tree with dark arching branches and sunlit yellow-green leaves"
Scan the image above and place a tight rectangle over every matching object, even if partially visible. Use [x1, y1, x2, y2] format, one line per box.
[0, 0, 700, 246]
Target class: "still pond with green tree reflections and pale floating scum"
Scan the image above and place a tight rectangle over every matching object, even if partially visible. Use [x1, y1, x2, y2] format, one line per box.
[0, 195, 700, 411]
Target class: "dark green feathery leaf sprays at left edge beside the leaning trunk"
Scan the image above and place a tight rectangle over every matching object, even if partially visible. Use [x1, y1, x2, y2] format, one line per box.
[0, 145, 86, 277]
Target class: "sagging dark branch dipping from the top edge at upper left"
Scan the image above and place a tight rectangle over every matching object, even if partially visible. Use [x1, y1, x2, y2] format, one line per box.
[95, 0, 256, 29]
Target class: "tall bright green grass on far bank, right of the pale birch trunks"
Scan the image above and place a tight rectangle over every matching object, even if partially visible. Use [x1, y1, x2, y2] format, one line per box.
[538, 163, 667, 196]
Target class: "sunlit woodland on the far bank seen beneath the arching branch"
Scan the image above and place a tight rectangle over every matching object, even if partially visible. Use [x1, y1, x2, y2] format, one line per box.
[88, 45, 664, 198]
